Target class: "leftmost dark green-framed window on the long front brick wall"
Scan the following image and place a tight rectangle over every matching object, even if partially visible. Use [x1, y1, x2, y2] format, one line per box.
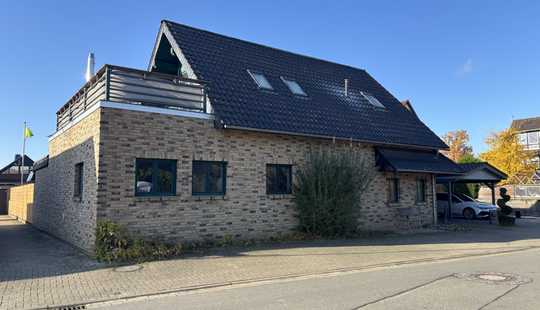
[135, 158, 176, 196]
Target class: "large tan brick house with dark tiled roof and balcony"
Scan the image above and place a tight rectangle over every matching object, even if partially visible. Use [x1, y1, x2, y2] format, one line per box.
[30, 21, 460, 251]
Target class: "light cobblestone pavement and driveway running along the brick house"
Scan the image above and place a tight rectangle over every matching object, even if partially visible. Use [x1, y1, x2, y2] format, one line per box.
[0, 217, 540, 309]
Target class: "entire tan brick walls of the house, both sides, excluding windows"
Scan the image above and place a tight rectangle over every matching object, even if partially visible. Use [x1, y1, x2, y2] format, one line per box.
[36, 107, 433, 250]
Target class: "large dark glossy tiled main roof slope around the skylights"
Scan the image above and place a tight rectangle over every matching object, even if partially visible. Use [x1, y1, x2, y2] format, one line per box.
[163, 21, 447, 149]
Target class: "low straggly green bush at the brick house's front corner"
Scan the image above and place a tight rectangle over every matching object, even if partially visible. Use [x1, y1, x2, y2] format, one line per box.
[96, 221, 183, 262]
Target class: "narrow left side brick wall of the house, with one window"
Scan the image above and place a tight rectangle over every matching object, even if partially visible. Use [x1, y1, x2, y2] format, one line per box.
[33, 110, 101, 252]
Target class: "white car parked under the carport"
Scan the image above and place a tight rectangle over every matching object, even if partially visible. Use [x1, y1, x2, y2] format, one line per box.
[437, 193, 497, 220]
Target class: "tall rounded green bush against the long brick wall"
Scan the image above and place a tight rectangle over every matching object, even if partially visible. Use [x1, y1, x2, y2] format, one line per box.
[294, 150, 375, 237]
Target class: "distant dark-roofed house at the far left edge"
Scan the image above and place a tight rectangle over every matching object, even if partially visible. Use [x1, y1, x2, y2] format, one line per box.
[0, 154, 34, 215]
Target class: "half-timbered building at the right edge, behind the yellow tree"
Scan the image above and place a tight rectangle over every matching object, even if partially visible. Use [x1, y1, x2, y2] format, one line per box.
[511, 117, 540, 169]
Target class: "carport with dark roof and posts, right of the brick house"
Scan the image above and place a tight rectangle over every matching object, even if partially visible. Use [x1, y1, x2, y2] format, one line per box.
[437, 162, 508, 220]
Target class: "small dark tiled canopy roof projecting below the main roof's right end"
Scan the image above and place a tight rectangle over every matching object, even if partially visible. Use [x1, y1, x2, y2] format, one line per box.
[375, 148, 463, 175]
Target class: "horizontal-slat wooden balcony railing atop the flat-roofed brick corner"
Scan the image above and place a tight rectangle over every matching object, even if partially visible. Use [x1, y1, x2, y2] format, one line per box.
[56, 65, 207, 130]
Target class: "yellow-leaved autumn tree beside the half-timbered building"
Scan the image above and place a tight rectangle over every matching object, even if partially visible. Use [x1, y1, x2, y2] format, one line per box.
[480, 128, 535, 183]
